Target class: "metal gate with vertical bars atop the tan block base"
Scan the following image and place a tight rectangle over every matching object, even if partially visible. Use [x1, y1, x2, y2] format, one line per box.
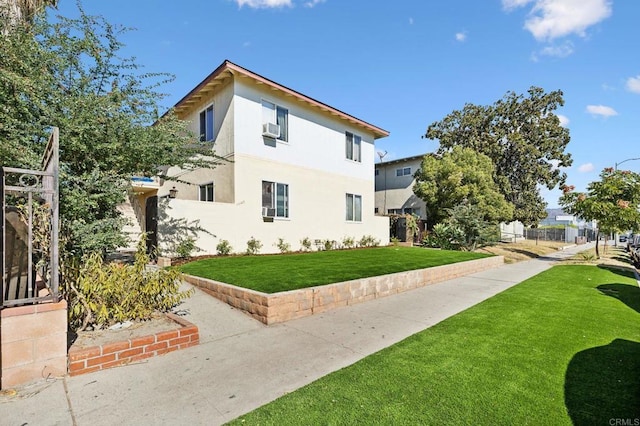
[0, 127, 60, 308]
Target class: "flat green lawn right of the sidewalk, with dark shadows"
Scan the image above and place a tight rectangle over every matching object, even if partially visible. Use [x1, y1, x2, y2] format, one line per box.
[234, 266, 640, 425]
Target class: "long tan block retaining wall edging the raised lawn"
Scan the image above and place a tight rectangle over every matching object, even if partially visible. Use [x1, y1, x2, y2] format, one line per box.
[185, 256, 504, 325]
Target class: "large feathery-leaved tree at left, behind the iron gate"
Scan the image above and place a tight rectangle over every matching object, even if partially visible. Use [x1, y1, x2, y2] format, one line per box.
[0, 6, 217, 256]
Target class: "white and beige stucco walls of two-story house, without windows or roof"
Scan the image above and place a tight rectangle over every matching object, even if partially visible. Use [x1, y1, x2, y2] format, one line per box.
[159, 73, 389, 253]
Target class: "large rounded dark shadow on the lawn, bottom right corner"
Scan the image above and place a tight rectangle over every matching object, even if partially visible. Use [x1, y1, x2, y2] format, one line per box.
[564, 339, 640, 425]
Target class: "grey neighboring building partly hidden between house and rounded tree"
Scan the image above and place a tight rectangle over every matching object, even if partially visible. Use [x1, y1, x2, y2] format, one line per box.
[375, 154, 427, 219]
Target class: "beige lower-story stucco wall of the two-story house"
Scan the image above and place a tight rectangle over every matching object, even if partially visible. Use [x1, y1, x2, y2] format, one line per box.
[160, 156, 389, 253]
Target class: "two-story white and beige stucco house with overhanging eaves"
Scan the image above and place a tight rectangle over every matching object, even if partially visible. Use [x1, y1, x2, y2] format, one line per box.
[129, 61, 389, 253]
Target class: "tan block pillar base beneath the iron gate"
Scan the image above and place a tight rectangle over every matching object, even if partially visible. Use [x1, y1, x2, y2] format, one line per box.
[0, 300, 67, 389]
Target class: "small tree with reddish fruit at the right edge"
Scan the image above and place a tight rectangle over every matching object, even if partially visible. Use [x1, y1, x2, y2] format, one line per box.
[560, 168, 640, 258]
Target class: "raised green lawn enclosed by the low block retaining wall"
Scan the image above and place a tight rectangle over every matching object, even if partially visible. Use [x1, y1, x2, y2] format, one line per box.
[180, 247, 487, 293]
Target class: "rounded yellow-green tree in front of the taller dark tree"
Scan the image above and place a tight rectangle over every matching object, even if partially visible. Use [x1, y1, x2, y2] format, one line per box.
[413, 146, 513, 229]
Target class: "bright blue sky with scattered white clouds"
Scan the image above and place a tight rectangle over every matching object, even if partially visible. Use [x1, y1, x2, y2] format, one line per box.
[53, 0, 640, 207]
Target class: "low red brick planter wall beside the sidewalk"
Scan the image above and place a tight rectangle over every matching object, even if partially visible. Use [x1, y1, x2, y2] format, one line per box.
[69, 314, 200, 376]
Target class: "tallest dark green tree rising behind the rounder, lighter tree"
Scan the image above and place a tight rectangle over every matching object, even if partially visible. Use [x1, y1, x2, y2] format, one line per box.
[425, 87, 572, 225]
